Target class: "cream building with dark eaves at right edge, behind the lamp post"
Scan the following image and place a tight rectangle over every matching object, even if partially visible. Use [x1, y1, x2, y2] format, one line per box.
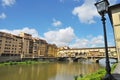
[108, 4, 120, 61]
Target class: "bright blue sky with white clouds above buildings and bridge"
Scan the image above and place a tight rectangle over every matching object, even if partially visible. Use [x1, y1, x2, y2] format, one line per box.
[0, 0, 120, 48]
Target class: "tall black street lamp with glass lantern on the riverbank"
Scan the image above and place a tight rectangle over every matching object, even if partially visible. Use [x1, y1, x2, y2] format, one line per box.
[95, 0, 115, 80]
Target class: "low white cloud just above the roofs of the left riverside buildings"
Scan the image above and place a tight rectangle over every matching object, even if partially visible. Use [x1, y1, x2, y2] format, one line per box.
[0, 27, 39, 37]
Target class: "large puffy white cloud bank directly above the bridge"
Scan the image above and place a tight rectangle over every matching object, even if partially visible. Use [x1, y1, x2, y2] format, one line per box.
[44, 27, 109, 48]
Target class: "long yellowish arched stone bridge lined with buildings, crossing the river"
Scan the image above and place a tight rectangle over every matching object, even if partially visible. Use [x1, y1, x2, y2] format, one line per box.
[57, 47, 118, 62]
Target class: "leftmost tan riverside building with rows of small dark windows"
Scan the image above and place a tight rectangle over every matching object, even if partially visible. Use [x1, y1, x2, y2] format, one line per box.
[0, 32, 22, 55]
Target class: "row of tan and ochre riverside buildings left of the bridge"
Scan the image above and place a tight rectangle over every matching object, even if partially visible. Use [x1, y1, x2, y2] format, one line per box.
[0, 32, 57, 58]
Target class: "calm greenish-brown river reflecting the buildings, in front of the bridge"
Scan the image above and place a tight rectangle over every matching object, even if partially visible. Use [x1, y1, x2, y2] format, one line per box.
[0, 58, 116, 80]
